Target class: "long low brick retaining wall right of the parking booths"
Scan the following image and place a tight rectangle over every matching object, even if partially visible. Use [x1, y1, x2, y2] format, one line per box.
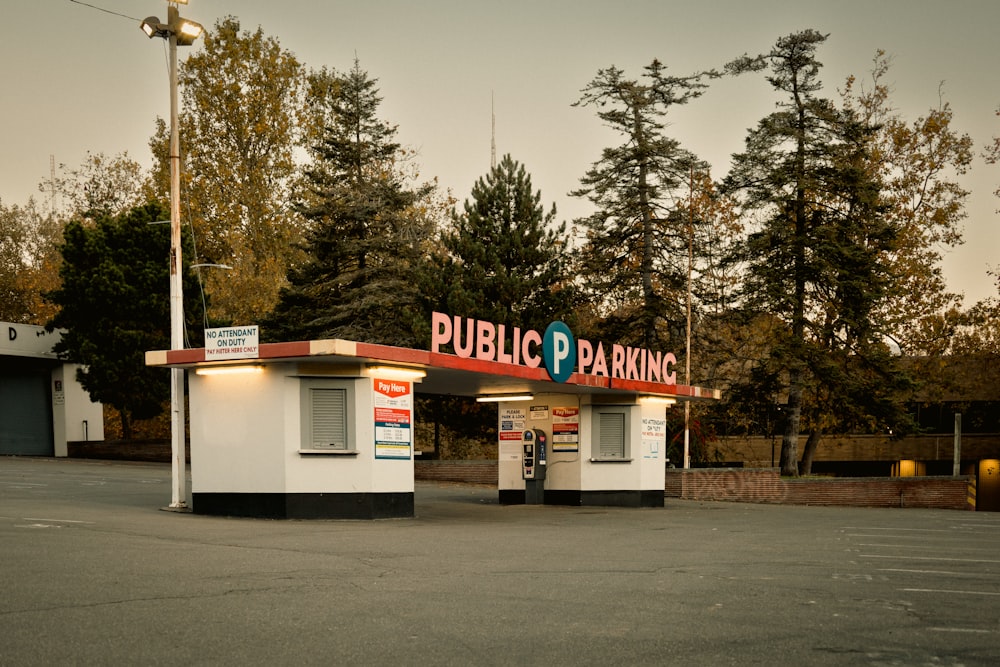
[665, 468, 976, 510]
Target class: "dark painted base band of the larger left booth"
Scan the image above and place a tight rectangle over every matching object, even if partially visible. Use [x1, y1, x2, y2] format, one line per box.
[192, 492, 413, 519]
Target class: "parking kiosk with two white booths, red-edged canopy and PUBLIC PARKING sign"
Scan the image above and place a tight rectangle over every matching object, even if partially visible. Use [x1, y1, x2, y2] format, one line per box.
[146, 314, 719, 519]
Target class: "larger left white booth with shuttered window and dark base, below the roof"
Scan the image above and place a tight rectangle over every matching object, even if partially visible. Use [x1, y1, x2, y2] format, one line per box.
[189, 363, 414, 519]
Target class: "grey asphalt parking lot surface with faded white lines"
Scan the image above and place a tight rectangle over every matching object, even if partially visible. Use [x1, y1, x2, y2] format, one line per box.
[0, 457, 1000, 666]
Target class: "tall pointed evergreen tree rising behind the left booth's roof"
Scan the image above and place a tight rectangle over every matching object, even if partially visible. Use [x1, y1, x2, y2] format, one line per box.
[262, 61, 431, 346]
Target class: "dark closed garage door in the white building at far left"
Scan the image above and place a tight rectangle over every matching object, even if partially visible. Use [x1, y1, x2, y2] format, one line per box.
[0, 372, 55, 456]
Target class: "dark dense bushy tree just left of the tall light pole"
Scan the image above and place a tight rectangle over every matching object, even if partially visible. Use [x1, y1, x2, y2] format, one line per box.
[46, 204, 203, 439]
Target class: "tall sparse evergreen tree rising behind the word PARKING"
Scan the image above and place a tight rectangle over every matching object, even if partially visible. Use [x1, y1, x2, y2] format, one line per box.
[572, 60, 714, 349]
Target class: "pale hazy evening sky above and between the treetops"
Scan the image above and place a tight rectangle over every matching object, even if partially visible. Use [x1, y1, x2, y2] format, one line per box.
[0, 0, 1000, 305]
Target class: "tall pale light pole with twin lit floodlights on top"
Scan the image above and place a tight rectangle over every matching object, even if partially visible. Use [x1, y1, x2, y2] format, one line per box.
[139, 0, 203, 509]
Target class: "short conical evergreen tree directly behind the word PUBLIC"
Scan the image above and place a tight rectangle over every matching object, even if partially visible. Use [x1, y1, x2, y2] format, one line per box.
[425, 155, 574, 330]
